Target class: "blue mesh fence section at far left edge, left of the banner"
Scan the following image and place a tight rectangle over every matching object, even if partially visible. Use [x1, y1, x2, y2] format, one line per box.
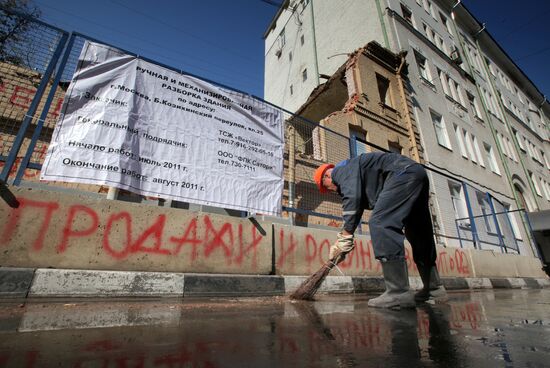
[0, 7, 67, 181]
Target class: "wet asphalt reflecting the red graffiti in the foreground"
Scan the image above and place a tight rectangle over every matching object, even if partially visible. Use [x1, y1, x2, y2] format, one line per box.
[0, 289, 550, 368]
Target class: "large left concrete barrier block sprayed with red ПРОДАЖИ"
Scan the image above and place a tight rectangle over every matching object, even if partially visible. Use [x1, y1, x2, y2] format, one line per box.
[0, 188, 272, 274]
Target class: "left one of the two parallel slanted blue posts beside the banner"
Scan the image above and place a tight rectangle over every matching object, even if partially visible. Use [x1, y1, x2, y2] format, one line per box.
[0, 33, 68, 182]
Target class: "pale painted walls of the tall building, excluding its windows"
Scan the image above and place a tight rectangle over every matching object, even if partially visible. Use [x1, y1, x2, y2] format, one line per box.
[265, 0, 550, 254]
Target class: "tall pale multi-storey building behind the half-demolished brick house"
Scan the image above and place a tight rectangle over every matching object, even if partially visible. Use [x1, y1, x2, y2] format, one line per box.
[264, 0, 550, 255]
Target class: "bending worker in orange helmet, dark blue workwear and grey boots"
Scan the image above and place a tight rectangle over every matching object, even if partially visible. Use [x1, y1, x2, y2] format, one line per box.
[314, 152, 447, 308]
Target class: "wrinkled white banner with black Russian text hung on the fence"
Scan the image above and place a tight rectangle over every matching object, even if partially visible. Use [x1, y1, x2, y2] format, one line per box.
[41, 42, 284, 215]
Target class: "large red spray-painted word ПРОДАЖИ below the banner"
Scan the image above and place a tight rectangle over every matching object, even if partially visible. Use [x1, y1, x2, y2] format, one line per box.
[0, 197, 264, 268]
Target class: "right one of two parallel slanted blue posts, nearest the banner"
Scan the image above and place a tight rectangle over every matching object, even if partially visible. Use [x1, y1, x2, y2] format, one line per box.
[13, 34, 75, 185]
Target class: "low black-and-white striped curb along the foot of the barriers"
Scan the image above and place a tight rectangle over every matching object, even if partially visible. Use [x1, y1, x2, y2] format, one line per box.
[0, 267, 550, 298]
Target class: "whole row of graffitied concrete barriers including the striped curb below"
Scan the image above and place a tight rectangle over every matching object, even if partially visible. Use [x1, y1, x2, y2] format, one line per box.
[0, 188, 550, 297]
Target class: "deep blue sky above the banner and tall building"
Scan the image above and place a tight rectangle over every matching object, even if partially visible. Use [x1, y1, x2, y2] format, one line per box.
[34, 0, 550, 99]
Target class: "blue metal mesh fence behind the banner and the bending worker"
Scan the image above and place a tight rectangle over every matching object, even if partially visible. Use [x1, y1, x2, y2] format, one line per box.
[0, 9, 536, 252]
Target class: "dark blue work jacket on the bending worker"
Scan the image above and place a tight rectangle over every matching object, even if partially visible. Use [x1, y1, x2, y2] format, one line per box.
[332, 152, 416, 233]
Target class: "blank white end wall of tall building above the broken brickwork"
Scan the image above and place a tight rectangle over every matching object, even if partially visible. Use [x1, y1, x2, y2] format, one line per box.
[264, 0, 384, 111]
